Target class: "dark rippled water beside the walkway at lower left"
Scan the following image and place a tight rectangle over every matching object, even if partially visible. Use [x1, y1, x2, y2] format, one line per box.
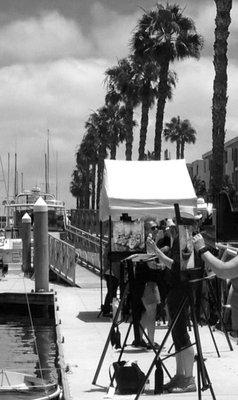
[0, 310, 58, 383]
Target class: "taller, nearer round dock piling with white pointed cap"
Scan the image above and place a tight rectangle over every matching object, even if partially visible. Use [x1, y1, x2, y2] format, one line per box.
[33, 197, 49, 292]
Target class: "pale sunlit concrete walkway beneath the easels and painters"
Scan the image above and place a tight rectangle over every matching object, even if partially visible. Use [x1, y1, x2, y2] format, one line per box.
[54, 270, 238, 400]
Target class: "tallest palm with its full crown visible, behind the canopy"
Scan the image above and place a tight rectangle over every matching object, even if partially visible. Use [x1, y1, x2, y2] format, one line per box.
[132, 3, 203, 159]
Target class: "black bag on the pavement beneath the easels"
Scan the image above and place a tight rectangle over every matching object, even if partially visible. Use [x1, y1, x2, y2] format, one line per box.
[109, 361, 145, 394]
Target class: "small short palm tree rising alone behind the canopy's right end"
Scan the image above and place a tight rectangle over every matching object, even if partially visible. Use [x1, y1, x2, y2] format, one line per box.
[164, 116, 197, 159]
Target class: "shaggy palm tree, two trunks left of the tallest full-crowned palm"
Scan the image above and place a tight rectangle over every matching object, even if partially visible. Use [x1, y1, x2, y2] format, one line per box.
[105, 58, 139, 160]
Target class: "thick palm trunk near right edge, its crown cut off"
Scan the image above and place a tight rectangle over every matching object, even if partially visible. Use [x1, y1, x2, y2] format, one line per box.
[211, 0, 232, 203]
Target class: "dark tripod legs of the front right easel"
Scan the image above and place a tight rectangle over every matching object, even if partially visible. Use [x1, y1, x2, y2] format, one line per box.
[134, 278, 216, 400]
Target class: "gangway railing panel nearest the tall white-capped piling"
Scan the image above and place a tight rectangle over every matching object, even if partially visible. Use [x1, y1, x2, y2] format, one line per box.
[48, 234, 76, 286]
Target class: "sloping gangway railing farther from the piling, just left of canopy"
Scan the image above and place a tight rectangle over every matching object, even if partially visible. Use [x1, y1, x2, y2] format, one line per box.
[66, 225, 107, 272]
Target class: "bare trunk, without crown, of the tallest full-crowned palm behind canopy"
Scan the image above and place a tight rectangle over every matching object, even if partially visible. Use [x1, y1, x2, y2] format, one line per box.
[154, 61, 169, 160]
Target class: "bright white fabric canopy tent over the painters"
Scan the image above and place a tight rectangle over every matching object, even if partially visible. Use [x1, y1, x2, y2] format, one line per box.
[99, 160, 197, 221]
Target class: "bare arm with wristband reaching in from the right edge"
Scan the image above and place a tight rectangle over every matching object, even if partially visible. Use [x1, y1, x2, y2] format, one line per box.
[193, 233, 238, 279]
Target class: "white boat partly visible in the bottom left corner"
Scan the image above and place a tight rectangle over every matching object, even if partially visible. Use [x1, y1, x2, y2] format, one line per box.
[0, 369, 62, 400]
